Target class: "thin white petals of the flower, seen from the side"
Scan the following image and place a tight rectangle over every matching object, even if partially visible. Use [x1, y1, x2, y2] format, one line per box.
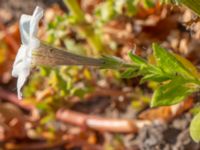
[12, 7, 43, 99]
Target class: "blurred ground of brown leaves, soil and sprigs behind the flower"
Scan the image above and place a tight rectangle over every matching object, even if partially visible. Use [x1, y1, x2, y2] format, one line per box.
[0, 0, 200, 150]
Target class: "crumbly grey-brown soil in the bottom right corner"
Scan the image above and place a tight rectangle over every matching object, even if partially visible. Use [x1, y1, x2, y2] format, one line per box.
[137, 114, 200, 150]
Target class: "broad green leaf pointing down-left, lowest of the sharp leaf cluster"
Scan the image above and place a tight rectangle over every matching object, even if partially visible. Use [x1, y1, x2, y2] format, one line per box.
[151, 77, 194, 107]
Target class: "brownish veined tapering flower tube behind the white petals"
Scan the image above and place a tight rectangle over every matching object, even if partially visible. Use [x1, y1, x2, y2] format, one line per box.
[32, 44, 104, 67]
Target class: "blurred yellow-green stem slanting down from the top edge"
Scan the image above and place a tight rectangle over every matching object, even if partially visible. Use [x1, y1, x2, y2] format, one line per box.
[64, 0, 105, 56]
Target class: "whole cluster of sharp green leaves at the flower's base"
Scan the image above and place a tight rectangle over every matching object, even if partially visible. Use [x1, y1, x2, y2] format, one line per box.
[121, 44, 199, 107]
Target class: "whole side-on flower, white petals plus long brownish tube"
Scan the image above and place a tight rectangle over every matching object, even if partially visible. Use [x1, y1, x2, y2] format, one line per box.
[12, 7, 123, 99]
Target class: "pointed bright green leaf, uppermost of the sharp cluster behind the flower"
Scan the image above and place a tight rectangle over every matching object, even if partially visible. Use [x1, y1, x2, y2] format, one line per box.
[152, 43, 194, 79]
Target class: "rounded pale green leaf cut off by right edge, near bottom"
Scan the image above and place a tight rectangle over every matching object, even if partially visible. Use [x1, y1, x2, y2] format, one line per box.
[190, 113, 200, 142]
